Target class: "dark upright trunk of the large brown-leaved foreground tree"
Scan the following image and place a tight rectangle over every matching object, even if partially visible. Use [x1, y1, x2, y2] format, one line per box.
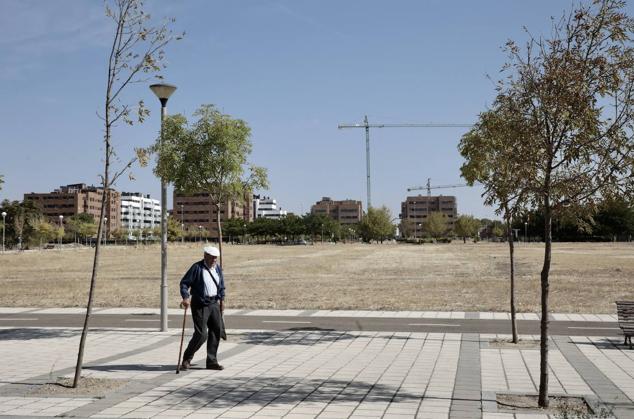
[539, 202, 552, 408]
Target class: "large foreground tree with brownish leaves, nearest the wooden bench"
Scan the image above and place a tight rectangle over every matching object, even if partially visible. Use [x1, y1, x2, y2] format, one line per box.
[466, 0, 634, 407]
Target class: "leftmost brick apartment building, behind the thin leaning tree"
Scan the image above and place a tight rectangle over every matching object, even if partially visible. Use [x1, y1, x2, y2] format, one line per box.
[24, 183, 121, 233]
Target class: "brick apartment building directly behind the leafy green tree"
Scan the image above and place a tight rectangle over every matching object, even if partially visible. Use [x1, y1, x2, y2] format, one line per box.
[172, 192, 253, 239]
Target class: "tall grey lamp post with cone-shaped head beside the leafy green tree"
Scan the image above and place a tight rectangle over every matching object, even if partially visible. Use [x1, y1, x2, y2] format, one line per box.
[150, 83, 176, 332]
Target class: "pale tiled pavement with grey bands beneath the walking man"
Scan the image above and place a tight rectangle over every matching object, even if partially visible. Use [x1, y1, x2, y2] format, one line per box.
[0, 309, 634, 419]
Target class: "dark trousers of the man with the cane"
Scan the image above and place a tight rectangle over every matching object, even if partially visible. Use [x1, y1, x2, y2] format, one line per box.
[183, 301, 222, 365]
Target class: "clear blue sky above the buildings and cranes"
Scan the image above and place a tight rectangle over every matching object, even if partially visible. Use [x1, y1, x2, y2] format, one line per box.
[0, 0, 632, 217]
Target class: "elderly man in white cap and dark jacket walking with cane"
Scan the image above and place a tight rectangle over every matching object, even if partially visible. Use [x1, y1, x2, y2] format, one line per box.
[180, 246, 225, 370]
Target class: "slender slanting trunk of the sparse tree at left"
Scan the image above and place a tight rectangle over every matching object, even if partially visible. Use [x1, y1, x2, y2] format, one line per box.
[73, 141, 110, 388]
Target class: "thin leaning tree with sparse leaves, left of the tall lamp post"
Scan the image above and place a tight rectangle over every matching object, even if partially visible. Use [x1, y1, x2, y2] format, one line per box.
[73, 0, 179, 387]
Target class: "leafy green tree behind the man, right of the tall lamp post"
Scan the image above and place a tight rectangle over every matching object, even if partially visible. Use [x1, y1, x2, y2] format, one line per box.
[154, 105, 268, 266]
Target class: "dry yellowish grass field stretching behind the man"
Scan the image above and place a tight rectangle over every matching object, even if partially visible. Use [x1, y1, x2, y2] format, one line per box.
[0, 243, 634, 313]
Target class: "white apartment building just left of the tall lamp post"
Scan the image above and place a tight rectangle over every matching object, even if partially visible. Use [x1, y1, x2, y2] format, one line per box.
[121, 192, 161, 232]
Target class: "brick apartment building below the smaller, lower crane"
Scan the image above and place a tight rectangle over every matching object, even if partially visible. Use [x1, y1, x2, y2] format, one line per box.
[401, 195, 458, 238]
